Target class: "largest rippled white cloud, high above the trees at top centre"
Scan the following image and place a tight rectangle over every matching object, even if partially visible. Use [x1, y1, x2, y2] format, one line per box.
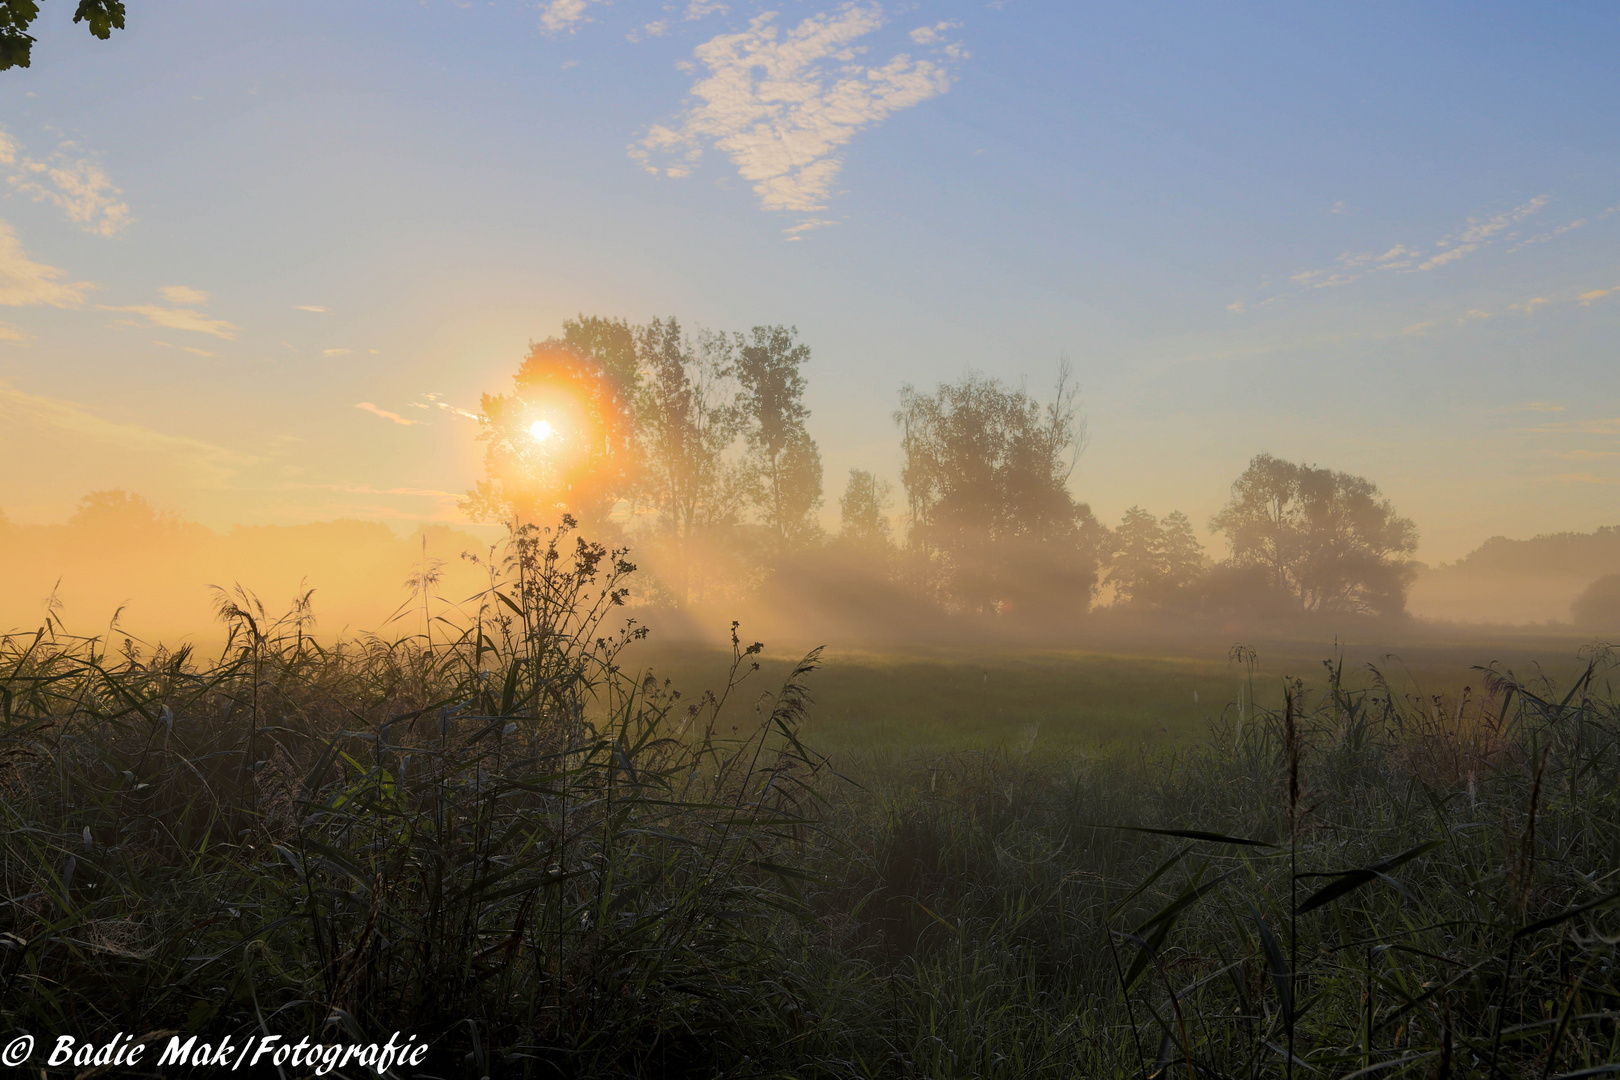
[630, 3, 953, 214]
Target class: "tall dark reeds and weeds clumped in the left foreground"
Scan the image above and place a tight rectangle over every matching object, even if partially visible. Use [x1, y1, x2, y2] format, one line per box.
[0, 526, 821, 1077]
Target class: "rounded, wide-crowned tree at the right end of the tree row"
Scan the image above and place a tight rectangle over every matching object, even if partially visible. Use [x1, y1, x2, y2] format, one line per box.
[1210, 453, 1418, 615]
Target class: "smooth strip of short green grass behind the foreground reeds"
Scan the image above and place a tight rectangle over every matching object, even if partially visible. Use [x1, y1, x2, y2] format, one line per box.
[625, 635, 1589, 758]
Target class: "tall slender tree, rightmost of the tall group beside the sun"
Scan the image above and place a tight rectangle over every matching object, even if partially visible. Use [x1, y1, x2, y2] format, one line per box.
[735, 325, 821, 554]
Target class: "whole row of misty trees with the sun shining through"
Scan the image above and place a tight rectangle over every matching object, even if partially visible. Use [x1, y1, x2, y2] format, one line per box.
[486, 316, 1418, 623]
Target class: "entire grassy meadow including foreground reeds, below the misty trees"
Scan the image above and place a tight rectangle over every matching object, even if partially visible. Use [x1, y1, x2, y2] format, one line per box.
[0, 534, 1620, 1080]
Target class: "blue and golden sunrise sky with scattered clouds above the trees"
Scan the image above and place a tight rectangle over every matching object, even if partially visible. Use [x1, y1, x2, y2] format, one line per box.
[0, 0, 1620, 563]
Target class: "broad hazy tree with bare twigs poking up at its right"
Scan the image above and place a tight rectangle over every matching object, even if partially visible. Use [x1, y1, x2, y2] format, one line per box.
[894, 364, 1100, 614]
